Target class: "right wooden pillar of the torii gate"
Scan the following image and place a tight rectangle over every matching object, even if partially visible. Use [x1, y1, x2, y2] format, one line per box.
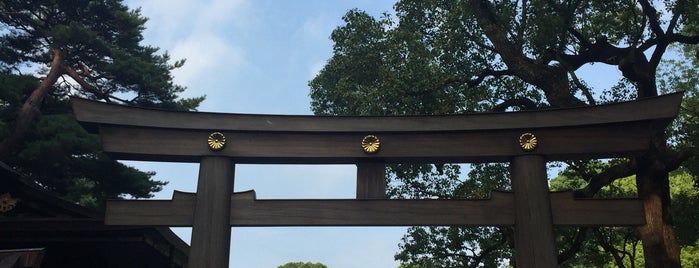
[510, 155, 558, 268]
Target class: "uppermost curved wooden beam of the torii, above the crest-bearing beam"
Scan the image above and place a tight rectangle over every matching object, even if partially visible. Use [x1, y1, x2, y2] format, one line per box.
[71, 93, 683, 133]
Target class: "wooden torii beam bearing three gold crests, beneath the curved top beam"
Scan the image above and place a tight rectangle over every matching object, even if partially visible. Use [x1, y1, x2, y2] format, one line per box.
[100, 122, 653, 164]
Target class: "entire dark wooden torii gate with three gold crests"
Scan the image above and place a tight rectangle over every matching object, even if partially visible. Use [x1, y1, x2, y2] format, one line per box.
[71, 93, 682, 267]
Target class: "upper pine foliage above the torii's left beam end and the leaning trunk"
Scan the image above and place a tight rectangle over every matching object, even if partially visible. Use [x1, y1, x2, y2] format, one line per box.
[0, 0, 202, 110]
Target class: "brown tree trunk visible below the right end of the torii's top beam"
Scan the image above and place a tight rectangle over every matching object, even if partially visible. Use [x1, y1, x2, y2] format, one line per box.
[636, 134, 681, 268]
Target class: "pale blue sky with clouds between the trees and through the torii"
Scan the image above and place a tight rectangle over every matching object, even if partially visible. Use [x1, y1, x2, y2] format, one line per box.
[120, 0, 405, 268]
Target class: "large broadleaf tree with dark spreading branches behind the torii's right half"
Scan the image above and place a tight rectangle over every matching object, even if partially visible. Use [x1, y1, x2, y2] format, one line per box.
[309, 0, 699, 267]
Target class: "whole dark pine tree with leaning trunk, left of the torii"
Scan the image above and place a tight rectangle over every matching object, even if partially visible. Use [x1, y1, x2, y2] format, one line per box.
[0, 0, 203, 206]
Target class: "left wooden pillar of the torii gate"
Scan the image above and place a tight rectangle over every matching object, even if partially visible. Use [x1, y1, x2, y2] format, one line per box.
[187, 157, 235, 268]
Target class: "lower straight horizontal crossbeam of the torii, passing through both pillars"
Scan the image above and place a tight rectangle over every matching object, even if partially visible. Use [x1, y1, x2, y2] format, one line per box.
[105, 191, 645, 227]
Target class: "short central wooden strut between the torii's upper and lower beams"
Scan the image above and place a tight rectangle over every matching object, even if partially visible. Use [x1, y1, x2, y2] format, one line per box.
[357, 162, 386, 199]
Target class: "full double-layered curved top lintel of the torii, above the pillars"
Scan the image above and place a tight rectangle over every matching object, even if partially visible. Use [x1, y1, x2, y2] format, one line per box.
[71, 93, 683, 164]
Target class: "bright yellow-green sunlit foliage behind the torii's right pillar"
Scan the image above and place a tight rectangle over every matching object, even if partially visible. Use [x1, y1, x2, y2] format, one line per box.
[550, 168, 699, 268]
